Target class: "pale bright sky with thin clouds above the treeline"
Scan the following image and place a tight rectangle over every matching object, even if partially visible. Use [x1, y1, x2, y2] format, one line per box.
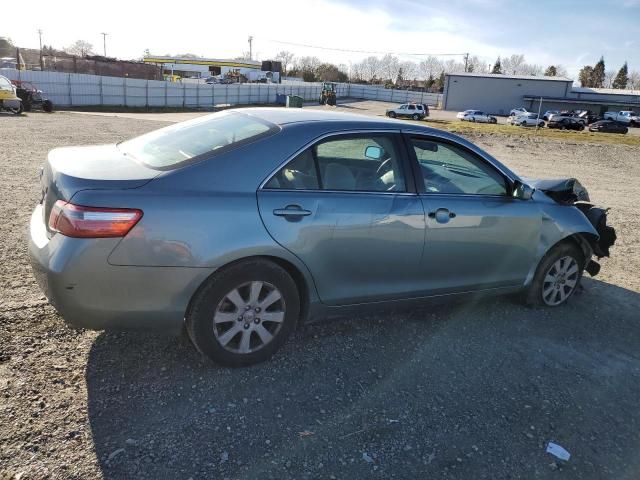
[0, 0, 640, 78]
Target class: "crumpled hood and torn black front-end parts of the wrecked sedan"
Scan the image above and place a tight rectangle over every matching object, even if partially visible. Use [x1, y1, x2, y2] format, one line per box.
[526, 178, 616, 276]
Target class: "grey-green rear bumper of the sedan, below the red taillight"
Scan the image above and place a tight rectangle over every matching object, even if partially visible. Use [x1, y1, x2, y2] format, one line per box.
[29, 205, 214, 333]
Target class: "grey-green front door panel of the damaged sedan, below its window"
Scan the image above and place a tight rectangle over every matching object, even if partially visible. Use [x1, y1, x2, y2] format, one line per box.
[421, 195, 542, 294]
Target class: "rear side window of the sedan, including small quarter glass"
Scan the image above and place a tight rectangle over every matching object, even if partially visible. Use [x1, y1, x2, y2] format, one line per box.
[265, 134, 406, 192]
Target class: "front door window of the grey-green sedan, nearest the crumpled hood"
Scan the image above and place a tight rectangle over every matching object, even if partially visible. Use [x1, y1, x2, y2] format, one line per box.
[411, 137, 507, 195]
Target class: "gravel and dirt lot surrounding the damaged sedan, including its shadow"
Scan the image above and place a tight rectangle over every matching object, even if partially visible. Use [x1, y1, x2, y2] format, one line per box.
[0, 107, 640, 480]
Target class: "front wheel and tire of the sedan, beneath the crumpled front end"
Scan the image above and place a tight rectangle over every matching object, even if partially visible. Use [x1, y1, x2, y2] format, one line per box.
[526, 242, 585, 307]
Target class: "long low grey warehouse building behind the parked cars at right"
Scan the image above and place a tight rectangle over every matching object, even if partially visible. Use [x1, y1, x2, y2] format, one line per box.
[442, 73, 640, 115]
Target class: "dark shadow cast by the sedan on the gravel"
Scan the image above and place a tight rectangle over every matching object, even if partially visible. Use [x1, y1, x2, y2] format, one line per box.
[86, 279, 640, 480]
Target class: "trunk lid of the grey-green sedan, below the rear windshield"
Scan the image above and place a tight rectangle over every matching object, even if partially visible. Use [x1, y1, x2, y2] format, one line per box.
[40, 144, 162, 231]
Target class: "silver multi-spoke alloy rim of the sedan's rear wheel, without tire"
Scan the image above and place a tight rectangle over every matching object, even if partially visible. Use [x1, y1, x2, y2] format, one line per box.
[213, 281, 286, 354]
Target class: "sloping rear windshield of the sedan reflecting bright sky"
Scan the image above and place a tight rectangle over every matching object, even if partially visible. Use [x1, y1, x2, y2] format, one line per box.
[118, 112, 278, 170]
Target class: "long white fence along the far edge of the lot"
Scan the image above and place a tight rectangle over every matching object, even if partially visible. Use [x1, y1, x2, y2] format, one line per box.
[0, 69, 442, 108]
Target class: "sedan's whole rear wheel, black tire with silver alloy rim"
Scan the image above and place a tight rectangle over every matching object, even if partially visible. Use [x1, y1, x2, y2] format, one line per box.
[186, 259, 300, 367]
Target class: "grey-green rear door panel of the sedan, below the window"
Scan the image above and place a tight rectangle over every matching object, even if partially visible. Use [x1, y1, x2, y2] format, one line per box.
[258, 190, 425, 305]
